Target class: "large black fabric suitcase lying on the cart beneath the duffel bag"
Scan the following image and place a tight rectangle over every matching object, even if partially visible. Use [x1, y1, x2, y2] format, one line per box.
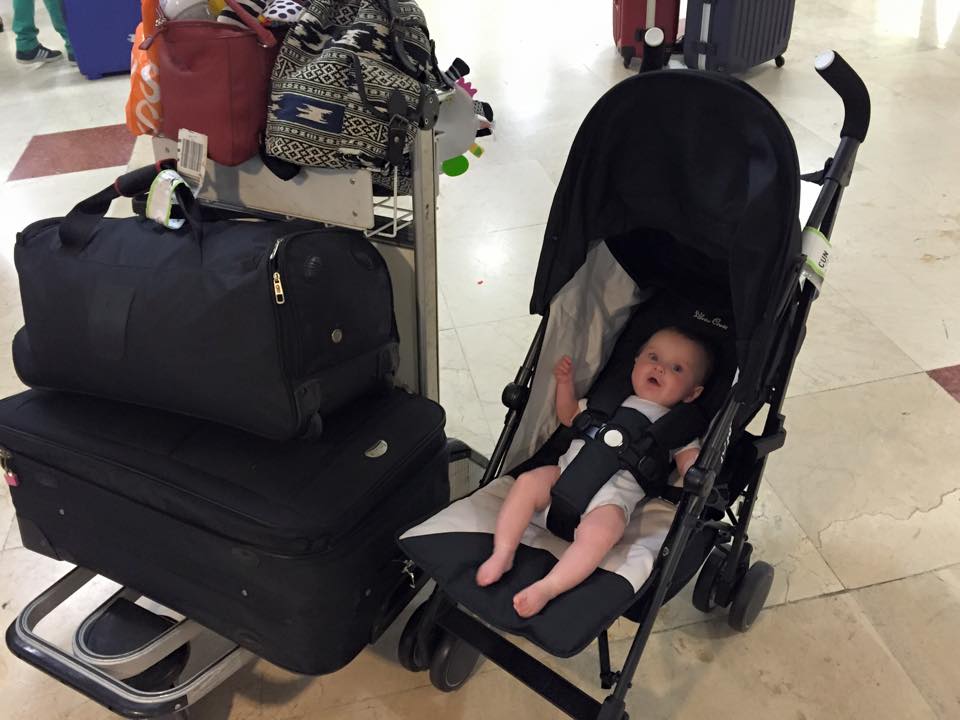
[0, 390, 449, 674]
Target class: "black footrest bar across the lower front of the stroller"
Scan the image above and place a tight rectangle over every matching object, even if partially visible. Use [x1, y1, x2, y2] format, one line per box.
[437, 607, 600, 720]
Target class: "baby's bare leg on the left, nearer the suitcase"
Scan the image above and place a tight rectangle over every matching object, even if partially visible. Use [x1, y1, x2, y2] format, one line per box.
[477, 465, 560, 587]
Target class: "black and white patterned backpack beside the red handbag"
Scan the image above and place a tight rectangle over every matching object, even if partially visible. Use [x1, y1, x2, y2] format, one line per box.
[266, 0, 454, 192]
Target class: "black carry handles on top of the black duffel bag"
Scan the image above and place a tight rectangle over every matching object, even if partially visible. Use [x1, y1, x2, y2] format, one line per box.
[60, 160, 203, 250]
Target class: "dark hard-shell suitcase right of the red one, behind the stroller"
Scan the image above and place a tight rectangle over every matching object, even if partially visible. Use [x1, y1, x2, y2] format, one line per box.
[683, 0, 796, 73]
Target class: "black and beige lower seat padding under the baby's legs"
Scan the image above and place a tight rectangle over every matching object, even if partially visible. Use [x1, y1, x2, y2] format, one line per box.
[400, 476, 676, 657]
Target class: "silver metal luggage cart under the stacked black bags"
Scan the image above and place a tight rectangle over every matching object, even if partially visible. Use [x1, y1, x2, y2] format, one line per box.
[0, 128, 442, 718]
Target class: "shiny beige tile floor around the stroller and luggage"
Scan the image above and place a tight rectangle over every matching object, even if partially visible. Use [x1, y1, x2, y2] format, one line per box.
[0, 0, 960, 720]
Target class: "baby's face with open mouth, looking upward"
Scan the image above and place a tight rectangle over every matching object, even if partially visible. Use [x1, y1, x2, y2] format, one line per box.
[630, 330, 706, 407]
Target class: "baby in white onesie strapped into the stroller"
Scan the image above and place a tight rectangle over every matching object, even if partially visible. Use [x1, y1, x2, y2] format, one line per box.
[477, 328, 712, 617]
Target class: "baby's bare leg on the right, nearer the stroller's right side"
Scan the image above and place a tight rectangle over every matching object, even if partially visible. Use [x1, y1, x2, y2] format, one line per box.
[513, 505, 627, 617]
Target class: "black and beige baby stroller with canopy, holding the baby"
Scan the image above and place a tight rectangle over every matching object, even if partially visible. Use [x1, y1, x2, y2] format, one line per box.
[400, 52, 870, 720]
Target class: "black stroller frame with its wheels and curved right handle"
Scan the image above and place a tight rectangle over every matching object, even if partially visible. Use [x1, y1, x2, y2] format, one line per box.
[400, 51, 870, 720]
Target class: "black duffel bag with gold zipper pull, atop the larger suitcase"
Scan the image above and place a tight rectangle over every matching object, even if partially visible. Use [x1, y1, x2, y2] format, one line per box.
[13, 165, 398, 439]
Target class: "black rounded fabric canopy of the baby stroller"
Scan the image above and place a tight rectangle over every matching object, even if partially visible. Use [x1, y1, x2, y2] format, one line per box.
[530, 70, 801, 398]
